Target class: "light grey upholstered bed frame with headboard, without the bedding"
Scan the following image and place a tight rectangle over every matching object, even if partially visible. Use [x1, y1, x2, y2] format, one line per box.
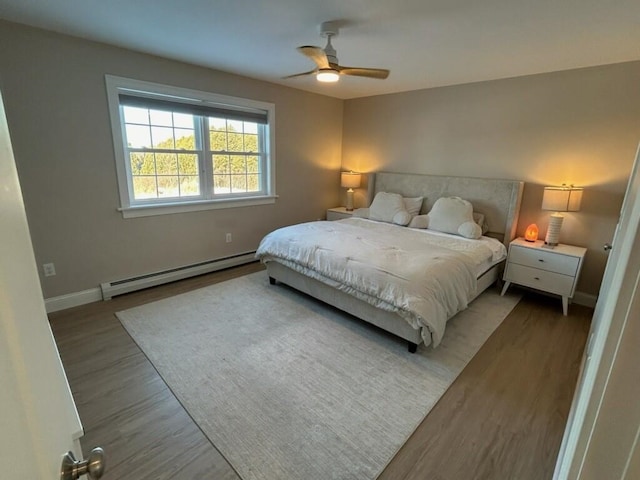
[266, 172, 524, 353]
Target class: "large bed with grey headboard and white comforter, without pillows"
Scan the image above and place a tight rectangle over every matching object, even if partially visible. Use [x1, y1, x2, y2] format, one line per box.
[256, 172, 524, 353]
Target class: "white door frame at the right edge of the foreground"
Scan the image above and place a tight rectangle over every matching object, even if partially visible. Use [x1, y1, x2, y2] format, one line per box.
[554, 146, 640, 480]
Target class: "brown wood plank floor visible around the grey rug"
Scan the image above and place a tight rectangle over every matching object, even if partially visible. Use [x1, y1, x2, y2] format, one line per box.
[49, 263, 593, 480]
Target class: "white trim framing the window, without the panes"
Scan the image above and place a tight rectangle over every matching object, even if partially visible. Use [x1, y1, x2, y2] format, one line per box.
[105, 75, 278, 218]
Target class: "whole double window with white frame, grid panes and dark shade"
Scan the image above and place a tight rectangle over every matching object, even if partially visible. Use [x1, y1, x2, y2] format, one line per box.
[106, 76, 275, 217]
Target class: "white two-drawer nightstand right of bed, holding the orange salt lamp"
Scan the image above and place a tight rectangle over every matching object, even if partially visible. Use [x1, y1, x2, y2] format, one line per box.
[501, 238, 587, 315]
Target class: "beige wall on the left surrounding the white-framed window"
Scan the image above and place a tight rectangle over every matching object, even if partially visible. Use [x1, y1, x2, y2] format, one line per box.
[0, 21, 343, 298]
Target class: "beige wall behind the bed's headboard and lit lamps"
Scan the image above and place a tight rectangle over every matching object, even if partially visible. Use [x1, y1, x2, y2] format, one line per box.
[342, 62, 640, 295]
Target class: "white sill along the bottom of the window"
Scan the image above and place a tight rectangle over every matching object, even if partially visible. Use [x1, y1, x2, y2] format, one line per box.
[118, 196, 278, 218]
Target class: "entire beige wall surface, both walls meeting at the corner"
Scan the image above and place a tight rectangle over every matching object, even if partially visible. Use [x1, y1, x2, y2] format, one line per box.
[0, 21, 640, 304]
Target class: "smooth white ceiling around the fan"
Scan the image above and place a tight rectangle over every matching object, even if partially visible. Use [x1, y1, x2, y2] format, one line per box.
[0, 0, 640, 99]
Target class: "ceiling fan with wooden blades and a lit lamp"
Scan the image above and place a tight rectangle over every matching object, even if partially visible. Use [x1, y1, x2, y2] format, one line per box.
[284, 22, 389, 82]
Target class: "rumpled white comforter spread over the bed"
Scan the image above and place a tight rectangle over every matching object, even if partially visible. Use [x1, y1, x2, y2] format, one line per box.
[256, 218, 504, 347]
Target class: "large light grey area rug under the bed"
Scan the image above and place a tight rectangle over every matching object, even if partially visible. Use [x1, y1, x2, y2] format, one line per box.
[117, 272, 520, 480]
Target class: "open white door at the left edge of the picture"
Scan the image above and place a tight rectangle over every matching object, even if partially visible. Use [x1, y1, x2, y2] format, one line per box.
[0, 87, 83, 480]
